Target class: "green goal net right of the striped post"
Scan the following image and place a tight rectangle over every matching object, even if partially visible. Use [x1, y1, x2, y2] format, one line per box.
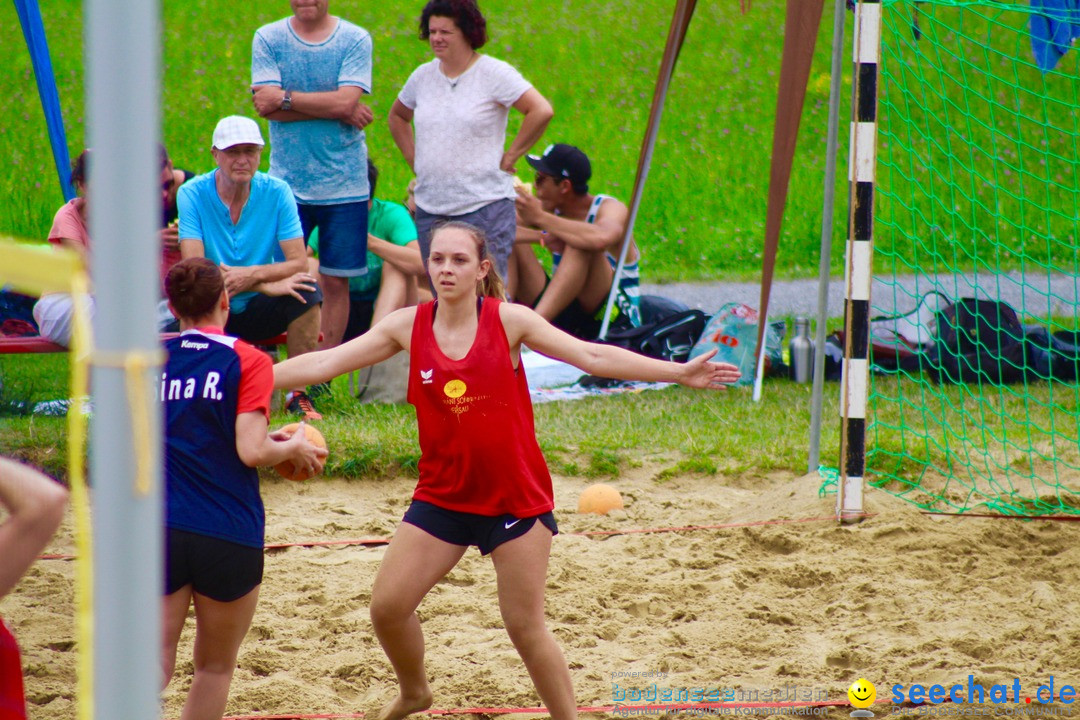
[866, 0, 1080, 515]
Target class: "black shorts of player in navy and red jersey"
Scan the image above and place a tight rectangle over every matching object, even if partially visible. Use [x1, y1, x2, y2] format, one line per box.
[165, 528, 262, 602]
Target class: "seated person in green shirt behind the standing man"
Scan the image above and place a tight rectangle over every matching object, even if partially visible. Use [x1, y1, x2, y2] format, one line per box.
[308, 160, 427, 341]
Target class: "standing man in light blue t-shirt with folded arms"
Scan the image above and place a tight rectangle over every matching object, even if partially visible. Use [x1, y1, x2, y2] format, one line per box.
[252, 0, 373, 348]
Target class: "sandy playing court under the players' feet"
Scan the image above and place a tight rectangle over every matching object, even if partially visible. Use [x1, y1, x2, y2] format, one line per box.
[10, 463, 1080, 720]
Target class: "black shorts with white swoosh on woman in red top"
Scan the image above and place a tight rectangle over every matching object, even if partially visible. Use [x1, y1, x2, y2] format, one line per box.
[402, 500, 558, 555]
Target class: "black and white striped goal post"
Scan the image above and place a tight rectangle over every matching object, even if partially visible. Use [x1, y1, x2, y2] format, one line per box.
[836, 0, 881, 522]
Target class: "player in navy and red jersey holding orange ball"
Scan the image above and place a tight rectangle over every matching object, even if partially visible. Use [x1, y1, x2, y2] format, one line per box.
[160, 258, 326, 720]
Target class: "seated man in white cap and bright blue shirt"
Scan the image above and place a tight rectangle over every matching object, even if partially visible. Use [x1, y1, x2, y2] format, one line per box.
[177, 116, 323, 420]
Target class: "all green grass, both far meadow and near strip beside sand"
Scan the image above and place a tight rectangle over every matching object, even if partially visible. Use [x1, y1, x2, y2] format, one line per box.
[0, 0, 1080, 504]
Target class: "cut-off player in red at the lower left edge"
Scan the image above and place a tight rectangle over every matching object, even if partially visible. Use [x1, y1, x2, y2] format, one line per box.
[0, 458, 67, 720]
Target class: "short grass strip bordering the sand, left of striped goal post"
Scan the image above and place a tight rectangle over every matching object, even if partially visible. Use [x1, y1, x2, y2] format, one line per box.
[0, 354, 839, 481]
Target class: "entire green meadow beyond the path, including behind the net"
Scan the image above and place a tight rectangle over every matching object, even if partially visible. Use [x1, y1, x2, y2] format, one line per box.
[0, 0, 1080, 282]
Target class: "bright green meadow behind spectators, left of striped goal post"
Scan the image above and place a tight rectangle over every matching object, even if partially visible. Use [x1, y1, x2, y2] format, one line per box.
[0, 0, 850, 282]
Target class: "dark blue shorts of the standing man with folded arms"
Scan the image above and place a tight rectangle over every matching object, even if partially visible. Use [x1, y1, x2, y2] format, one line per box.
[296, 200, 367, 277]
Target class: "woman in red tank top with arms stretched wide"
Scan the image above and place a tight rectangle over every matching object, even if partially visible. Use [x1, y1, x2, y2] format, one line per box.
[274, 222, 739, 720]
